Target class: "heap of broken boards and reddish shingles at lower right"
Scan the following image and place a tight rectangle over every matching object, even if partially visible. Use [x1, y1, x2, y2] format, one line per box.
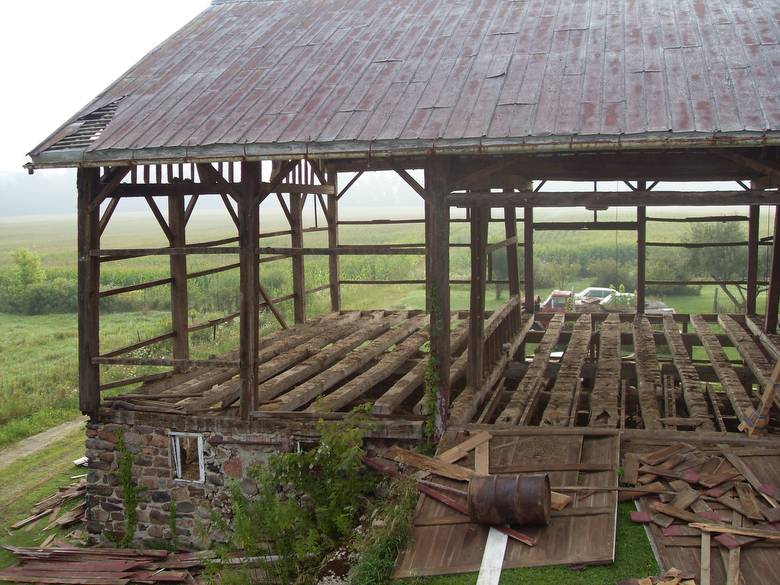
[621, 443, 780, 585]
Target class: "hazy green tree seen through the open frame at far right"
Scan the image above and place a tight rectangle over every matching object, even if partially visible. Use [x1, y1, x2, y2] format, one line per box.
[685, 222, 747, 311]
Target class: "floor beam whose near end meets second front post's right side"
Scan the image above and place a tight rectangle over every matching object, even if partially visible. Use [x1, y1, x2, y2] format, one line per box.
[257, 312, 396, 410]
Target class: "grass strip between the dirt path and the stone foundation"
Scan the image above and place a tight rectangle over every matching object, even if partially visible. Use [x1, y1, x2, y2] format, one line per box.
[0, 430, 85, 567]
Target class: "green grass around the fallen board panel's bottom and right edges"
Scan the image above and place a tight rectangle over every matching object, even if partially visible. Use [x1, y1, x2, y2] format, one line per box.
[402, 502, 659, 585]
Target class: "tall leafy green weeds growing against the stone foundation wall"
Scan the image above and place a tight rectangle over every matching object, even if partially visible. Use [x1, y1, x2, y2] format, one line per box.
[221, 411, 378, 585]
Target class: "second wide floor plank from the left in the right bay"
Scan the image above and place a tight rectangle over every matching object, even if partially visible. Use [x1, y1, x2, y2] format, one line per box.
[540, 313, 591, 426]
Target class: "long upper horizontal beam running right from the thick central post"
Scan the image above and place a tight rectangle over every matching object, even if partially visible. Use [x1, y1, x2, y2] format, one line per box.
[447, 190, 780, 207]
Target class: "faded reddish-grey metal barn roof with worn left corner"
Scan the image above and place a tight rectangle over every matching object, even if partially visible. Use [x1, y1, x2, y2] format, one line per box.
[30, 0, 780, 166]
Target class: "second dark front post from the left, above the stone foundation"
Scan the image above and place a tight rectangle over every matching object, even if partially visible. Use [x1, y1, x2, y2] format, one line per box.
[238, 162, 261, 419]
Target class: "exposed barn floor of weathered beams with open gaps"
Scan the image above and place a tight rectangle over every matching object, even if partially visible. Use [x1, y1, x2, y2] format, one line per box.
[105, 309, 780, 432]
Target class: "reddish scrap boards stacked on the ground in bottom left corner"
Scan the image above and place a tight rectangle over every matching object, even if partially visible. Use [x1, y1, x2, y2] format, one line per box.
[0, 545, 208, 585]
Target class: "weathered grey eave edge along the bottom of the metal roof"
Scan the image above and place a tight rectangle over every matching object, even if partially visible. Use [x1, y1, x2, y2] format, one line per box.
[25, 132, 780, 170]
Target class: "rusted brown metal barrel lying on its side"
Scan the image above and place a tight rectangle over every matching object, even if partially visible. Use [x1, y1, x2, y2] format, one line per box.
[468, 473, 550, 526]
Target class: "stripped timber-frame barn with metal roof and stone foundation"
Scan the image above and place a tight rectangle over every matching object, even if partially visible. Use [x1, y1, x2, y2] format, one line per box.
[22, 0, 780, 542]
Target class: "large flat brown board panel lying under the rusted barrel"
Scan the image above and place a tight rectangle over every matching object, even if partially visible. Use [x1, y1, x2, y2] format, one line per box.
[394, 429, 619, 578]
